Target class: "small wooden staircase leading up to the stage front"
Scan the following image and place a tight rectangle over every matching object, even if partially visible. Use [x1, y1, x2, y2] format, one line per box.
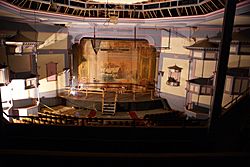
[102, 92, 117, 115]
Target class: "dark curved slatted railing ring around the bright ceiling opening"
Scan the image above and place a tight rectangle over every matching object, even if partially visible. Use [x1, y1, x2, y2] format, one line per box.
[1, 0, 235, 19]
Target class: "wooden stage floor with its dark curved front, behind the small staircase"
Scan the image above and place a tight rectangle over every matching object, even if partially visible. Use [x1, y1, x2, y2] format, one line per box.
[60, 92, 170, 112]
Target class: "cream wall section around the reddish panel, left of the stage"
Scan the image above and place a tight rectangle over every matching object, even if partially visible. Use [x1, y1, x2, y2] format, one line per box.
[37, 30, 69, 98]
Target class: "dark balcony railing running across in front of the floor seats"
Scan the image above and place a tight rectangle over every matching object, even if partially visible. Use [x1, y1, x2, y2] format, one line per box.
[2, 112, 207, 128]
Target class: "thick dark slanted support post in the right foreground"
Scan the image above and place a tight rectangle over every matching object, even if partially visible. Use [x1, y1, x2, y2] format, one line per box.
[208, 0, 236, 134]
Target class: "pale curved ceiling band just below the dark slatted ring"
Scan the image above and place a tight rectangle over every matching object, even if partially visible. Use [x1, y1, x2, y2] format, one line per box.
[0, 0, 250, 28]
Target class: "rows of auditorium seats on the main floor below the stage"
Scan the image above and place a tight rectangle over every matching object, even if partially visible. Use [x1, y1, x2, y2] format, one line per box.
[13, 107, 205, 127]
